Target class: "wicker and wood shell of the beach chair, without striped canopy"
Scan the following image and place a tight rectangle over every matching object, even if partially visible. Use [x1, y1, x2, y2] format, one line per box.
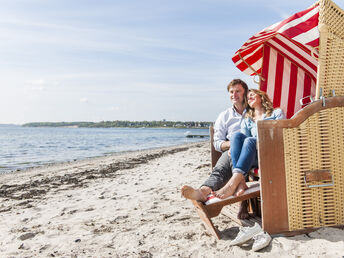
[258, 0, 344, 235]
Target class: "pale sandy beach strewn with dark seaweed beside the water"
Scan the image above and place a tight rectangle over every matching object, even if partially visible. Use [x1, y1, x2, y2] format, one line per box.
[0, 142, 344, 257]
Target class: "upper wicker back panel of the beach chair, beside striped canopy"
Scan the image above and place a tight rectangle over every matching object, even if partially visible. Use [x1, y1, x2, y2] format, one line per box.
[317, 0, 344, 97]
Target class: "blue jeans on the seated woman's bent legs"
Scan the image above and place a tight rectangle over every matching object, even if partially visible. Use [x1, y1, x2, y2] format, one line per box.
[230, 132, 258, 176]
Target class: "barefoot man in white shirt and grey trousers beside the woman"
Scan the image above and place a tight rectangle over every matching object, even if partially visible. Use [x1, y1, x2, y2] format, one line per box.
[181, 79, 248, 219]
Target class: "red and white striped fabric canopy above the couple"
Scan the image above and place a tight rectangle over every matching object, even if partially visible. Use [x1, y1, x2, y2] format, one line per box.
[232, 5, 319, 118]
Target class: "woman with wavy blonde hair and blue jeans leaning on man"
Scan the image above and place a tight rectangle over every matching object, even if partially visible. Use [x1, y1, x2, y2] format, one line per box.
[215, 89, 285, 199]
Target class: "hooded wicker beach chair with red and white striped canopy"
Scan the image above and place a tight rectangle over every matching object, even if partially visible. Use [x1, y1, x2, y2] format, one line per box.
[233, 0, 344, 235]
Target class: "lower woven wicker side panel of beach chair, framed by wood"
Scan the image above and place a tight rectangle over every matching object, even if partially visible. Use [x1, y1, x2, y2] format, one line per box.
[283, 107, 344, 231]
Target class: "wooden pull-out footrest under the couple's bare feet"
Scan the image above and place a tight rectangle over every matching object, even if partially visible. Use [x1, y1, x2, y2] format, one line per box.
[192, 183, 260, 239]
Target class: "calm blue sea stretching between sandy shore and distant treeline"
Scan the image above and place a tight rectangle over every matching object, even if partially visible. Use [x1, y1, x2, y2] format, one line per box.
[0, 125, 209, 173]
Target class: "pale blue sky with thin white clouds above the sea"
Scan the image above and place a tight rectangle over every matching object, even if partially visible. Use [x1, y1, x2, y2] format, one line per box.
[0, 0, 344, 124]
